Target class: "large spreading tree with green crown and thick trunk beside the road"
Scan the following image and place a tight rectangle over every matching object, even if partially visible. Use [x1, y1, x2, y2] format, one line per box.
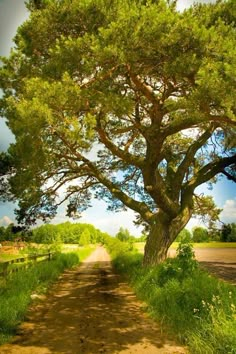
[0, 0, 236, 265]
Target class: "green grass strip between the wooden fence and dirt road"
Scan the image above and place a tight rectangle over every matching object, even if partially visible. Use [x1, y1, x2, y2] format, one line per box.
[0, 247, 93, 344]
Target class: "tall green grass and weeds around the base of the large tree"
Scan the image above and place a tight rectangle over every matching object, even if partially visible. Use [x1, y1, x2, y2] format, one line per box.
[105, 241, 236, 354]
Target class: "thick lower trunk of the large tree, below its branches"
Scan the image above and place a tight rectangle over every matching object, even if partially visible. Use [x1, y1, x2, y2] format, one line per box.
[143, 213, 190, 266]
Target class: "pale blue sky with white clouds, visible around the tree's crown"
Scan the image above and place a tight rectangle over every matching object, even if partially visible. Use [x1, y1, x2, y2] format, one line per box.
[0, 0, 236, 236]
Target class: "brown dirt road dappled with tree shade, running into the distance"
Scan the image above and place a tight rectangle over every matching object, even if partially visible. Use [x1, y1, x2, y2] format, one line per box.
[0, 247, 185, 354]
